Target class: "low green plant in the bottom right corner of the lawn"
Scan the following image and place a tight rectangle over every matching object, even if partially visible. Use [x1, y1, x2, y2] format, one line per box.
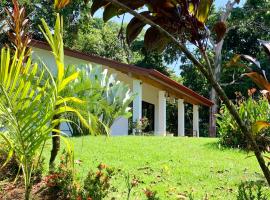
[237, 182, 268, 200]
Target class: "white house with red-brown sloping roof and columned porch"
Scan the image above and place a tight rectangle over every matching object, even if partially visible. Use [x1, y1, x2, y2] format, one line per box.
[31, 40, 213, 137]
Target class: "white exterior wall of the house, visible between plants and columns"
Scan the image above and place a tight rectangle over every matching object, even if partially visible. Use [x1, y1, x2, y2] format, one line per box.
[32, 48, 159, 135]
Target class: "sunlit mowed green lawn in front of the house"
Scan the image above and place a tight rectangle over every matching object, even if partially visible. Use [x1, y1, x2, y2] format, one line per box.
[45, 136, 270, 199]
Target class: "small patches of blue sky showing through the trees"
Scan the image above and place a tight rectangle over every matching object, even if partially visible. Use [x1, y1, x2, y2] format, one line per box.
[95, 0, 246, 75]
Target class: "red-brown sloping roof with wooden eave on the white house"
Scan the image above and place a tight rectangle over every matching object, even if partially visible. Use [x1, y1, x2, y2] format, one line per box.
[30, 40, 213, 106]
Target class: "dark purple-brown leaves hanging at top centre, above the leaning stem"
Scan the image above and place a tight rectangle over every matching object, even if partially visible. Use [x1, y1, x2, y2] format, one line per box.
[91, 0, 212, 51]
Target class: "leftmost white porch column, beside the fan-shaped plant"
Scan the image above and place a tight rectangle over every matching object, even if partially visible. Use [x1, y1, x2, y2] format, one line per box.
[132, 80, 142, 125]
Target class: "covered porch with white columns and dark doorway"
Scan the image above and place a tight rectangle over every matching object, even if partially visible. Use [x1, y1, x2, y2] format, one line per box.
[130, 79, 210, 137]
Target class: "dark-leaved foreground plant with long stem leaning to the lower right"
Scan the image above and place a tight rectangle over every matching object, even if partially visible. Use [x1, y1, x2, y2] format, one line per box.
[59, 0, 270, 185]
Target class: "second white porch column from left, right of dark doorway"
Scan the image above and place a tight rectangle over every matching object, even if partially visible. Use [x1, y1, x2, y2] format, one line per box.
[156, 91, 166, 136]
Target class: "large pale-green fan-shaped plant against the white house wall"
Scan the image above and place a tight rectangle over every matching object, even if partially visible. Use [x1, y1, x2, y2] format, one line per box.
[65, 64, 133, 136]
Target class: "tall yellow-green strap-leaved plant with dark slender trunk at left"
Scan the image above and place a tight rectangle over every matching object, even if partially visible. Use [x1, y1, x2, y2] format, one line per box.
[40, 14, 89, 169]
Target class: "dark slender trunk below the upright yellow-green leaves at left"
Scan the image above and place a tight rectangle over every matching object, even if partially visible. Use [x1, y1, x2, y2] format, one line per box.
[49, 115, 60, 169]
